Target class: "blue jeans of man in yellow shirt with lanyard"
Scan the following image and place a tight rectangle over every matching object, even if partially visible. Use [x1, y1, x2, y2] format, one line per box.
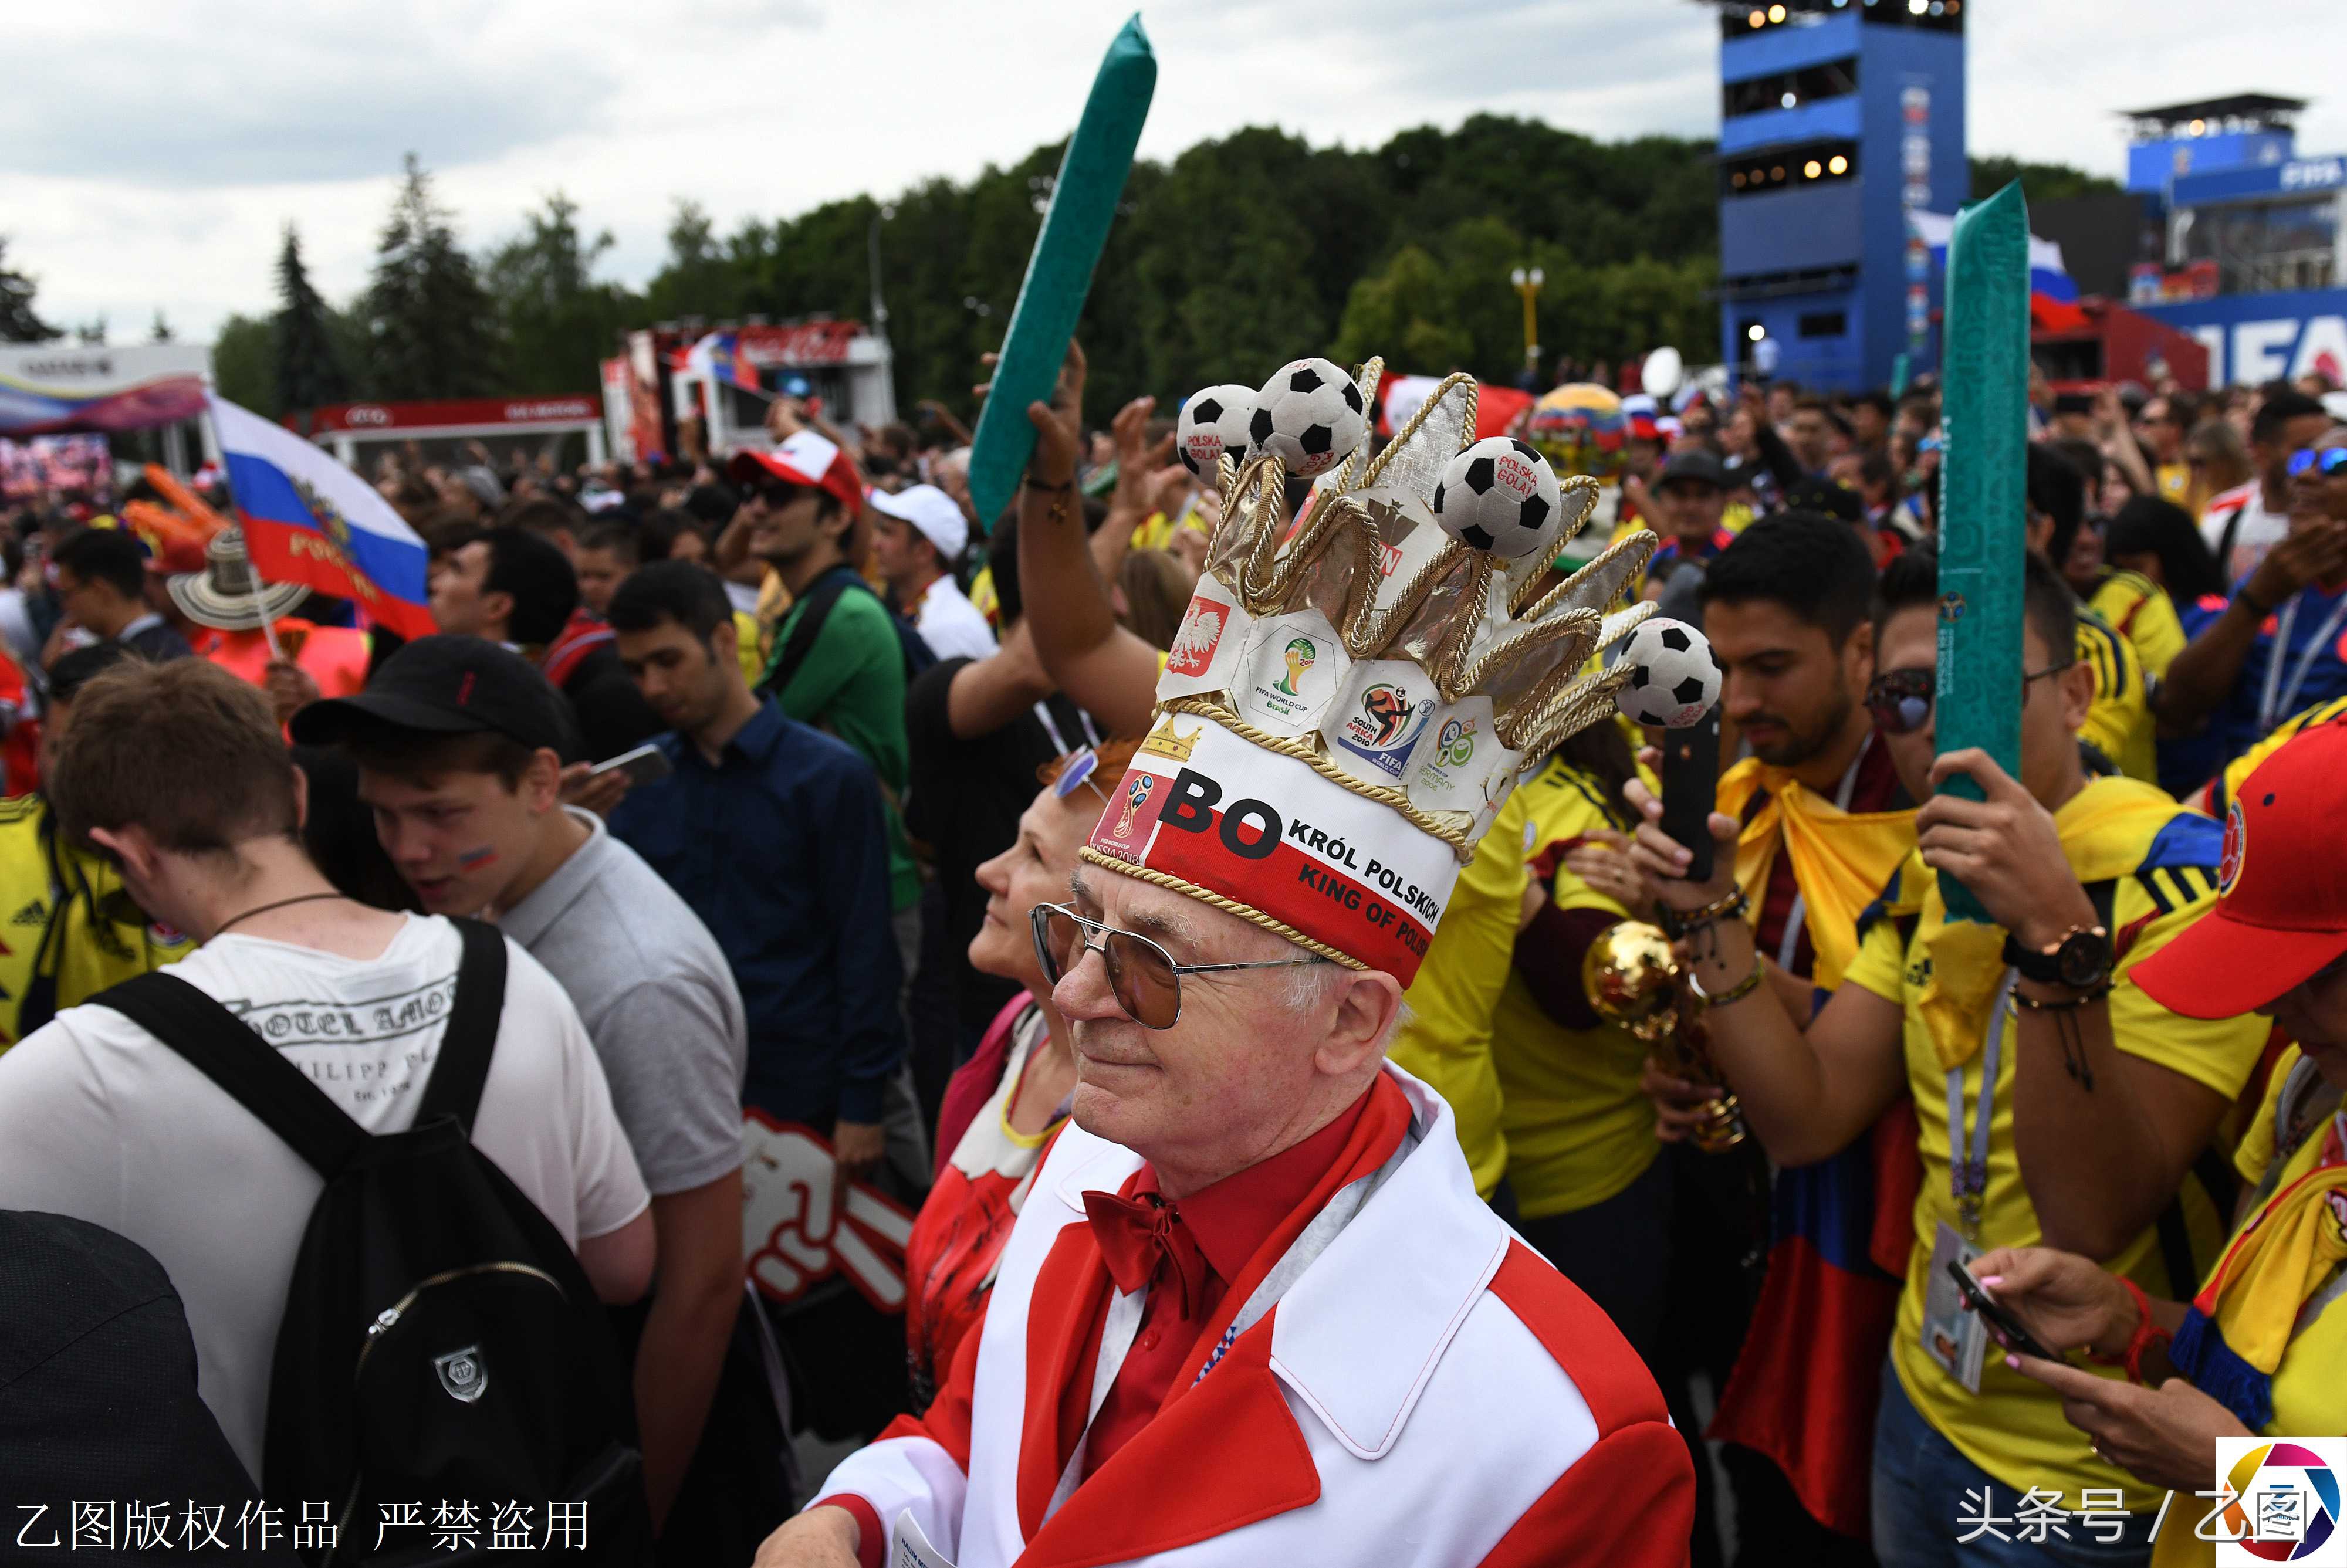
[1873, 1364, 2159, 1568]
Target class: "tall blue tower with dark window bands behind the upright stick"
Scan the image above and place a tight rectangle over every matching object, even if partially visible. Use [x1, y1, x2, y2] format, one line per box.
[1718, 0, 1971, 392]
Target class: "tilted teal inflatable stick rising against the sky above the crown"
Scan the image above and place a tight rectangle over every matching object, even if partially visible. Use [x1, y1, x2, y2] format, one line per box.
[969, 12, 1157, 521]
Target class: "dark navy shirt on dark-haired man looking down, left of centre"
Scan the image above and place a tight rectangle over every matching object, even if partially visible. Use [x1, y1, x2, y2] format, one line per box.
[610, 702, 906, 1132]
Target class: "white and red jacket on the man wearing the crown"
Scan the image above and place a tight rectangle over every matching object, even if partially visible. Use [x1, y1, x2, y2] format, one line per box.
[817, 1066, 1695, 1568]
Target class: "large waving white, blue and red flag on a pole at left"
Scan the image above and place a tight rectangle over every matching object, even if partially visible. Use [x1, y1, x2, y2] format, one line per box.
[211, 394, 439, 638]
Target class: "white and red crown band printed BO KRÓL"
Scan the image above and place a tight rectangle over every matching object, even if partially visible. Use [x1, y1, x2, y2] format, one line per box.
[1091, 709, 1460, 986]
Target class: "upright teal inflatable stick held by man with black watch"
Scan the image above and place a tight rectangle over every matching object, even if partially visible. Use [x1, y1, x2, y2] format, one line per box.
[1936, 181, 2030, 923]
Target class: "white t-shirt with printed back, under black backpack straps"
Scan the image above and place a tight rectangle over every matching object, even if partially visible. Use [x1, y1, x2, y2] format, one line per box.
[0, 916, 650, 1476]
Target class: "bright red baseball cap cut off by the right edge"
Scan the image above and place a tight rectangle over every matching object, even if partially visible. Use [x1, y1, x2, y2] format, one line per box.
[2129, 720, 2347, 1019]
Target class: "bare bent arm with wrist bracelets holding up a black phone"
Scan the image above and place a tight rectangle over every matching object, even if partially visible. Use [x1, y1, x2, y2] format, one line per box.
[1622, 779, 1906, 1164]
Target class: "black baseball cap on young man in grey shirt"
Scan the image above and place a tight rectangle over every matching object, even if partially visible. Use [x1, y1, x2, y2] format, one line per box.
[289, 634, 570, 753]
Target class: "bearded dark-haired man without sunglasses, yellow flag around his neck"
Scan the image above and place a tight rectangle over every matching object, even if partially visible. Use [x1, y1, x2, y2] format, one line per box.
[1671, 512, 1915, 1563]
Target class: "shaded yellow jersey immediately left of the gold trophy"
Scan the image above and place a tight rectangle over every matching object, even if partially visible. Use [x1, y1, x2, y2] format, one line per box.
[1483, 756, 1662, 1218]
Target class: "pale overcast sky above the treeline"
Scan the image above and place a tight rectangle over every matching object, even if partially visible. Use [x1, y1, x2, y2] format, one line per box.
[0, 0, 2347, 343]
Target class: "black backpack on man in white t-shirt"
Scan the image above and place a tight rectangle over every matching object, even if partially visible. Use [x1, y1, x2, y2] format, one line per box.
[92, 920, 652, 1566]
